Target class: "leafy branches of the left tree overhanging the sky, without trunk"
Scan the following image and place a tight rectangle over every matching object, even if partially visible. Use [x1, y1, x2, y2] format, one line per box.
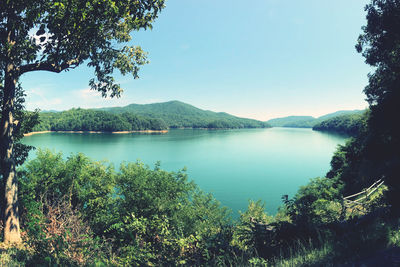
[0, 0, 164, 96]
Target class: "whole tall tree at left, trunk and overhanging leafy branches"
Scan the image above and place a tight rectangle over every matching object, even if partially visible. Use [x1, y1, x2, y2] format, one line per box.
[0, 0, 164, 242]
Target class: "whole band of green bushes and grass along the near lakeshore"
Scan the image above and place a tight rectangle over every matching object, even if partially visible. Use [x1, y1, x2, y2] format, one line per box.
[0, 150, 394, 266]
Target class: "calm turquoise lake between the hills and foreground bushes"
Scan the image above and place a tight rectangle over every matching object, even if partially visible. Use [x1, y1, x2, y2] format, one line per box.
[23, 128, 345, 218]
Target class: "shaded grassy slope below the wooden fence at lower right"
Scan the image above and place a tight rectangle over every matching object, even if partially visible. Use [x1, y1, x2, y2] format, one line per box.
[249, 218, 400, 267]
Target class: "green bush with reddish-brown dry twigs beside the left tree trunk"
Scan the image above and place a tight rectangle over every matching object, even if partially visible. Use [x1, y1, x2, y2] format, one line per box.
[19, 151, 114, 265]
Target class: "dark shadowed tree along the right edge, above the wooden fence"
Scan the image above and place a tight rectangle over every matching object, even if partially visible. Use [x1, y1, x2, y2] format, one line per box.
[356, 0, 400, 207]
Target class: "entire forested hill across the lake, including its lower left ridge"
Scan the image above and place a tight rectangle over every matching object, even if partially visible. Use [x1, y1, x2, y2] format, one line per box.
[34, 101, 270, 132]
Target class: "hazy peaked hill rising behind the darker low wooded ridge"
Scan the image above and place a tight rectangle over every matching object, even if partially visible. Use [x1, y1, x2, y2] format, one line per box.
[100, 101, 270, 128]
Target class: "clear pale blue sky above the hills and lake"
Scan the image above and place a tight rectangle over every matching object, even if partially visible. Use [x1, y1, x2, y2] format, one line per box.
[22, 0, 371, 120]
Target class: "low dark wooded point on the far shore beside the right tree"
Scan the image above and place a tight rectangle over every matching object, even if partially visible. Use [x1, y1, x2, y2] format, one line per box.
[313, 112, 367, 136]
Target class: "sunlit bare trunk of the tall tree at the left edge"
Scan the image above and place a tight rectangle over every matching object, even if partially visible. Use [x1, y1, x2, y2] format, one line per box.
[0, 64, 21, 243]
